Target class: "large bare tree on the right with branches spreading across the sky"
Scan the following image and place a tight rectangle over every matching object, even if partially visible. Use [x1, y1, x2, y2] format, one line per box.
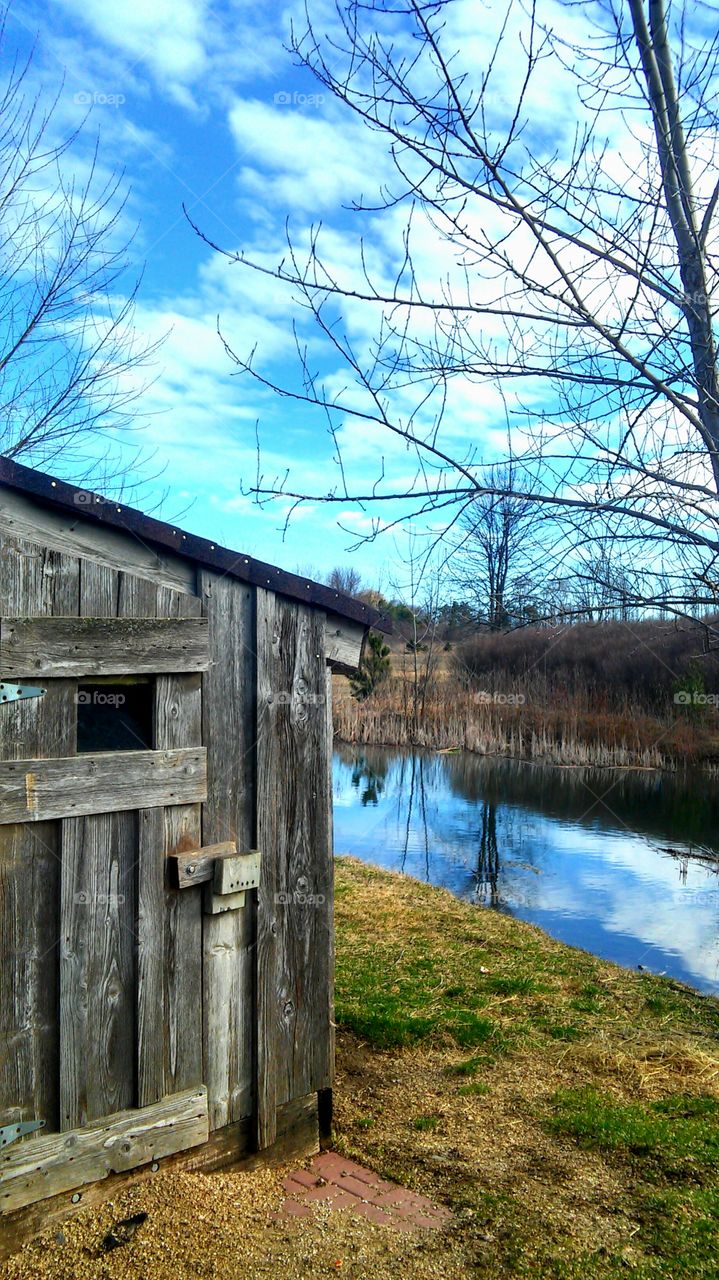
[194, 0, 719, 624]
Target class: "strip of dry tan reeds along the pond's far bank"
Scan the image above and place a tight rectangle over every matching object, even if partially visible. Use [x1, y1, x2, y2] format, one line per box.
[334, 672, 719, 769]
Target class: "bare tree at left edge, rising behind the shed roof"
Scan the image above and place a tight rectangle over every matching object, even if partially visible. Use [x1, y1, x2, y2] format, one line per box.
[0, 43, 156, 477]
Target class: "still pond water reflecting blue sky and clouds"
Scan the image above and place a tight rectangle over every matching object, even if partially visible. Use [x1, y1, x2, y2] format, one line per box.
[334, 746, 719, 993]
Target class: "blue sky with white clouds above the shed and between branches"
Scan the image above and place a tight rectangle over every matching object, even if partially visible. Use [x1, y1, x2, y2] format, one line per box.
[6, 0, 695, 594]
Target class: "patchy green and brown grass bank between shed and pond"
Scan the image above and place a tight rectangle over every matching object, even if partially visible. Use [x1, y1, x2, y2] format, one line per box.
[336, 859, 719, 1280]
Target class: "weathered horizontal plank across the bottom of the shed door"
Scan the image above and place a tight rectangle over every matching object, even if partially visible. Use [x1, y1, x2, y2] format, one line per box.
[0, 1088, 209, 1213]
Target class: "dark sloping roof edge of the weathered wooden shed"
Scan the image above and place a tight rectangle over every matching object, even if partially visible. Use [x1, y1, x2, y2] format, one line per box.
[0, 457, 391, 631]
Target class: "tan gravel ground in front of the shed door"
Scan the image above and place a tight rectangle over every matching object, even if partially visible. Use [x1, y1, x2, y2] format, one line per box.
[0, 1164, 458, 1280]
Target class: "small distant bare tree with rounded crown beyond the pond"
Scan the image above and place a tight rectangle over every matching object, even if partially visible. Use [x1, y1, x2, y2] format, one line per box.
[452, 467, 537, 631]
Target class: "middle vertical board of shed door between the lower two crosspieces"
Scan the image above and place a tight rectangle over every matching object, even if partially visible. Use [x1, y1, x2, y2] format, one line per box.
[60, 813, 137, 1130]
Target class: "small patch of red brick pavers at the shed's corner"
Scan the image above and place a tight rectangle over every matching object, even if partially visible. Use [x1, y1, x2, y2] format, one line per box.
[276, 1151, 452, 1231]
